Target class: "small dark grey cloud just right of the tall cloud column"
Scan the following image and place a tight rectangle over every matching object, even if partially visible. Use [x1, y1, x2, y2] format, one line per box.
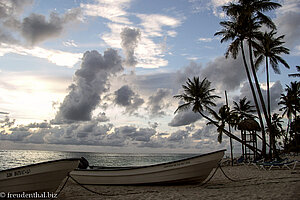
[114, 85, 144, 114]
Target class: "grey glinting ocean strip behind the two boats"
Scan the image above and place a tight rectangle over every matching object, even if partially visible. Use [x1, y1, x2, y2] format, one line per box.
[0, 150, 196, 170]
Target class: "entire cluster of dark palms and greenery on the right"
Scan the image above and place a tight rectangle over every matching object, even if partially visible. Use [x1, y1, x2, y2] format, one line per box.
[174, 0, 300, 158]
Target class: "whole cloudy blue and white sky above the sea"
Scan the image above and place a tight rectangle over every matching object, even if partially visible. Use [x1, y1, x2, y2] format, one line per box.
[0, 0, 300, 153]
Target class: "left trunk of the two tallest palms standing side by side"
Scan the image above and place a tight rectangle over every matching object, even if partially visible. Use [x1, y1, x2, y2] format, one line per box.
[241, 41, 266, 157]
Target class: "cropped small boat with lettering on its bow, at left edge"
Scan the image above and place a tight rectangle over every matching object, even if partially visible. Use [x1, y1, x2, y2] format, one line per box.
[0, 158, 80, 193]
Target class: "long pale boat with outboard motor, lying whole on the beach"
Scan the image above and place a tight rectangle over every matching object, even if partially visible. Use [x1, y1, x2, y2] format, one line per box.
[70, 150, 225, 185]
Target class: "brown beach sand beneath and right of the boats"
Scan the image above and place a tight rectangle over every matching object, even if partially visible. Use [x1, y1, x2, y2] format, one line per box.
[58, 163, 300, 200]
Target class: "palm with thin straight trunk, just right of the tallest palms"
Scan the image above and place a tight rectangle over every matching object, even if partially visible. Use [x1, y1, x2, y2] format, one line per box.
[253, 30, 290, 118]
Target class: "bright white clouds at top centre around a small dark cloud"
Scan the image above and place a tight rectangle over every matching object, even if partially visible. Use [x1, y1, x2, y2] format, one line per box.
[81, 0, 182, 68]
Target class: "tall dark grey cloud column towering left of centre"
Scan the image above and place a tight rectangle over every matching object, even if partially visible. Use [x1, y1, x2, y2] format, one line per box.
[54, 49, 123, 122]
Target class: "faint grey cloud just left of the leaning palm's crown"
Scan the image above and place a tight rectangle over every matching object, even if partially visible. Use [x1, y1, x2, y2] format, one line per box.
[147, 88, 172, 117]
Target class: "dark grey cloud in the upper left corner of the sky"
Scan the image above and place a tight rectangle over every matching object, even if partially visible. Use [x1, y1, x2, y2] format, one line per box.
[21, 8, 81, 45]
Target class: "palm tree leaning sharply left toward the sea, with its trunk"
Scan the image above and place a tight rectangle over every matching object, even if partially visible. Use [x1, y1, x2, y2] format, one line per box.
[174, 77, 262, 155]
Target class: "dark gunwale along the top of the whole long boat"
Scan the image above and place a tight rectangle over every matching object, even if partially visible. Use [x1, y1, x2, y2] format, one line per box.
[73, 149, 226, 172]
